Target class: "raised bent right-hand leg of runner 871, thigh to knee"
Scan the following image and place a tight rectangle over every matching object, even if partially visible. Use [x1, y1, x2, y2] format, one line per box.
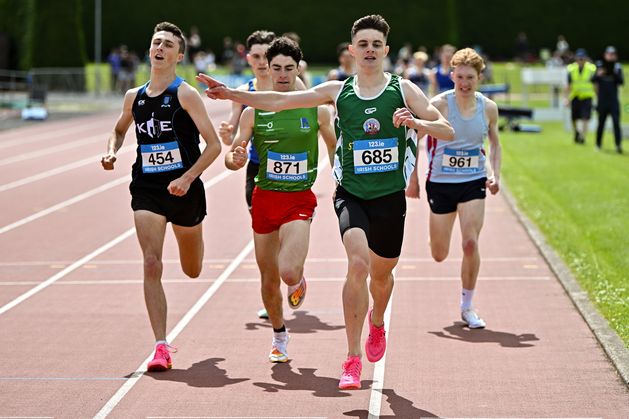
[278, 220, 310, 285]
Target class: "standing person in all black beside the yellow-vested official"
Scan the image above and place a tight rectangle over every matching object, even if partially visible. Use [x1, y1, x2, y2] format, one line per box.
[593, 46, 625, 154]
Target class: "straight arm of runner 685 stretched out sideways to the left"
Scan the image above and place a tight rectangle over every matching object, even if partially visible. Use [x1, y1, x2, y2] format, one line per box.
[197, 73, 343, 112]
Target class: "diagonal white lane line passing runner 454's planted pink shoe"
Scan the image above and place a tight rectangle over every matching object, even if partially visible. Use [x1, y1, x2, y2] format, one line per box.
[94, 240, 253, 418]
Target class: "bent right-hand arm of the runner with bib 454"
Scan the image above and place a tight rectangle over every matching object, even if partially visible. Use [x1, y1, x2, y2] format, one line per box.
[168, 83, 221, 196]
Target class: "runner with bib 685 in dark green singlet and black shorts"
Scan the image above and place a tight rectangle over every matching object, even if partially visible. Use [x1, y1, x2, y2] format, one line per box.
[197, 15, 454, 389]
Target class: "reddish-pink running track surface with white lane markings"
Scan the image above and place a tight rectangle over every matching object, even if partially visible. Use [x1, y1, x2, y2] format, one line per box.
[0, 102, 629, 418]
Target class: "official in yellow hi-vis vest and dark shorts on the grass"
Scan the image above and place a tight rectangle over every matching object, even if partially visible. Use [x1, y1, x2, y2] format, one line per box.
[566, 48, 596, 144]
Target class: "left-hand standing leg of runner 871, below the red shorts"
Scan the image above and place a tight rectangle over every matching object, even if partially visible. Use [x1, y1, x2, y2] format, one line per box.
[253, 231, 284, 329]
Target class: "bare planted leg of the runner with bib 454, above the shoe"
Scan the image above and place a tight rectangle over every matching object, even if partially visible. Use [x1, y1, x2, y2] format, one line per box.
[133, 210, 167, 340]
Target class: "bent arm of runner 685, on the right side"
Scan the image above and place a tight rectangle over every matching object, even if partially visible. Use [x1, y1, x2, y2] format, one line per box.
[393, 80, 454, 141]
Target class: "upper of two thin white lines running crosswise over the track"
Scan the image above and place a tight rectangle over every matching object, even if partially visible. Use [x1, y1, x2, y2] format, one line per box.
[0, 257, 542, 268]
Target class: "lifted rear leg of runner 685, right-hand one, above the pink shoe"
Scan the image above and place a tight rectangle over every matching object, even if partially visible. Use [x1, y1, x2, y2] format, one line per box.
[367, 251, 399, 327]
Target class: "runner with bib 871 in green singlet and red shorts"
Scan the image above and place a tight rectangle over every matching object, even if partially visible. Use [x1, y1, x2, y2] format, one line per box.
[225, 37, 336, 362]
